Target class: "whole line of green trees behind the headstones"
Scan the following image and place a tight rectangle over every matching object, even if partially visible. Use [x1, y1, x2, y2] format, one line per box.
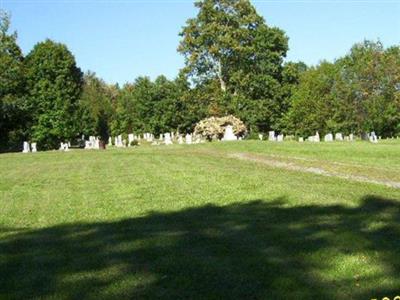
[0, 0, 400, 151]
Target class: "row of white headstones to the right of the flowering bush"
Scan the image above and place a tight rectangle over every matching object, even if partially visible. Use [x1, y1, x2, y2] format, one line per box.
[258, 131, 378, 143]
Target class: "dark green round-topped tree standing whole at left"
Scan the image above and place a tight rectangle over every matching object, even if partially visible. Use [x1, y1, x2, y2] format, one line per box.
[26, 40, 83, 149]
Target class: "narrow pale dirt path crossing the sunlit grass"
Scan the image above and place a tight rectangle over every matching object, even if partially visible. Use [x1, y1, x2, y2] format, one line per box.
[229, 153, 400, 189]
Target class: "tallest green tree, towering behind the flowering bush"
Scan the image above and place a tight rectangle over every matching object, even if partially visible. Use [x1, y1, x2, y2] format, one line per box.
[178, 0, 288, 130]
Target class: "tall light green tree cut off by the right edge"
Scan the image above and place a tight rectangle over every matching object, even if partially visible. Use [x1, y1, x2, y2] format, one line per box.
[335, 41, 400, 136]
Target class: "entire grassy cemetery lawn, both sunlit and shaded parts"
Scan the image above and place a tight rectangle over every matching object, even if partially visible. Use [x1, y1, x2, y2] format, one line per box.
[0, 140, 400, 299]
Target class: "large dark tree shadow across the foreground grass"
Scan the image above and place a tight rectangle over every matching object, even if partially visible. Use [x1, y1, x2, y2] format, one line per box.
[0, 196, 400, 299]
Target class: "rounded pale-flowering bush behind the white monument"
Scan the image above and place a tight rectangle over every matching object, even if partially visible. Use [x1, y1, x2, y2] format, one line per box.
[194, 115, 247, 140]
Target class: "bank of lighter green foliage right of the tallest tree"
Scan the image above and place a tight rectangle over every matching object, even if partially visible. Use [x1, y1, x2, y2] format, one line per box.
[285, 41, 400, 136]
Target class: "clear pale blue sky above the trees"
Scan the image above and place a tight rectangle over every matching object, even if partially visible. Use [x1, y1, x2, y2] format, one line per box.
[0, 0, 400, 85]
